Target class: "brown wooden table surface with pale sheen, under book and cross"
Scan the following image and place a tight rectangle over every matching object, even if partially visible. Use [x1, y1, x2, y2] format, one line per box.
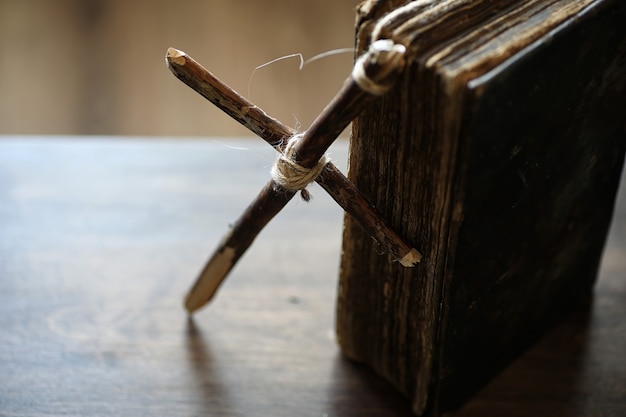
[0, 137, 626, 417]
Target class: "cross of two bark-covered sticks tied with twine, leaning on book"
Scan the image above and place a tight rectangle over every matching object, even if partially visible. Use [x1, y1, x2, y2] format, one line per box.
[166, 40, 422, 313]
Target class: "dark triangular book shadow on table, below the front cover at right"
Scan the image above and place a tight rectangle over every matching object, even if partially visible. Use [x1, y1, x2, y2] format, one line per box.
[454, 301, 599, 417]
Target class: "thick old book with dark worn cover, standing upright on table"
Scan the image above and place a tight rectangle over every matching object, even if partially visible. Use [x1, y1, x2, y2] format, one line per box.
[337, 0, 626, 415]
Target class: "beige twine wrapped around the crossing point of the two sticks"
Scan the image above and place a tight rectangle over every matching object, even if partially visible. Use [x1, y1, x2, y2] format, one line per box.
[271, 134, 330, 201]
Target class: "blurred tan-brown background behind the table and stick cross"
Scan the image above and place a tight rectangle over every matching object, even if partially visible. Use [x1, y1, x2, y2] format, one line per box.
[0, 0, 359, 136]
